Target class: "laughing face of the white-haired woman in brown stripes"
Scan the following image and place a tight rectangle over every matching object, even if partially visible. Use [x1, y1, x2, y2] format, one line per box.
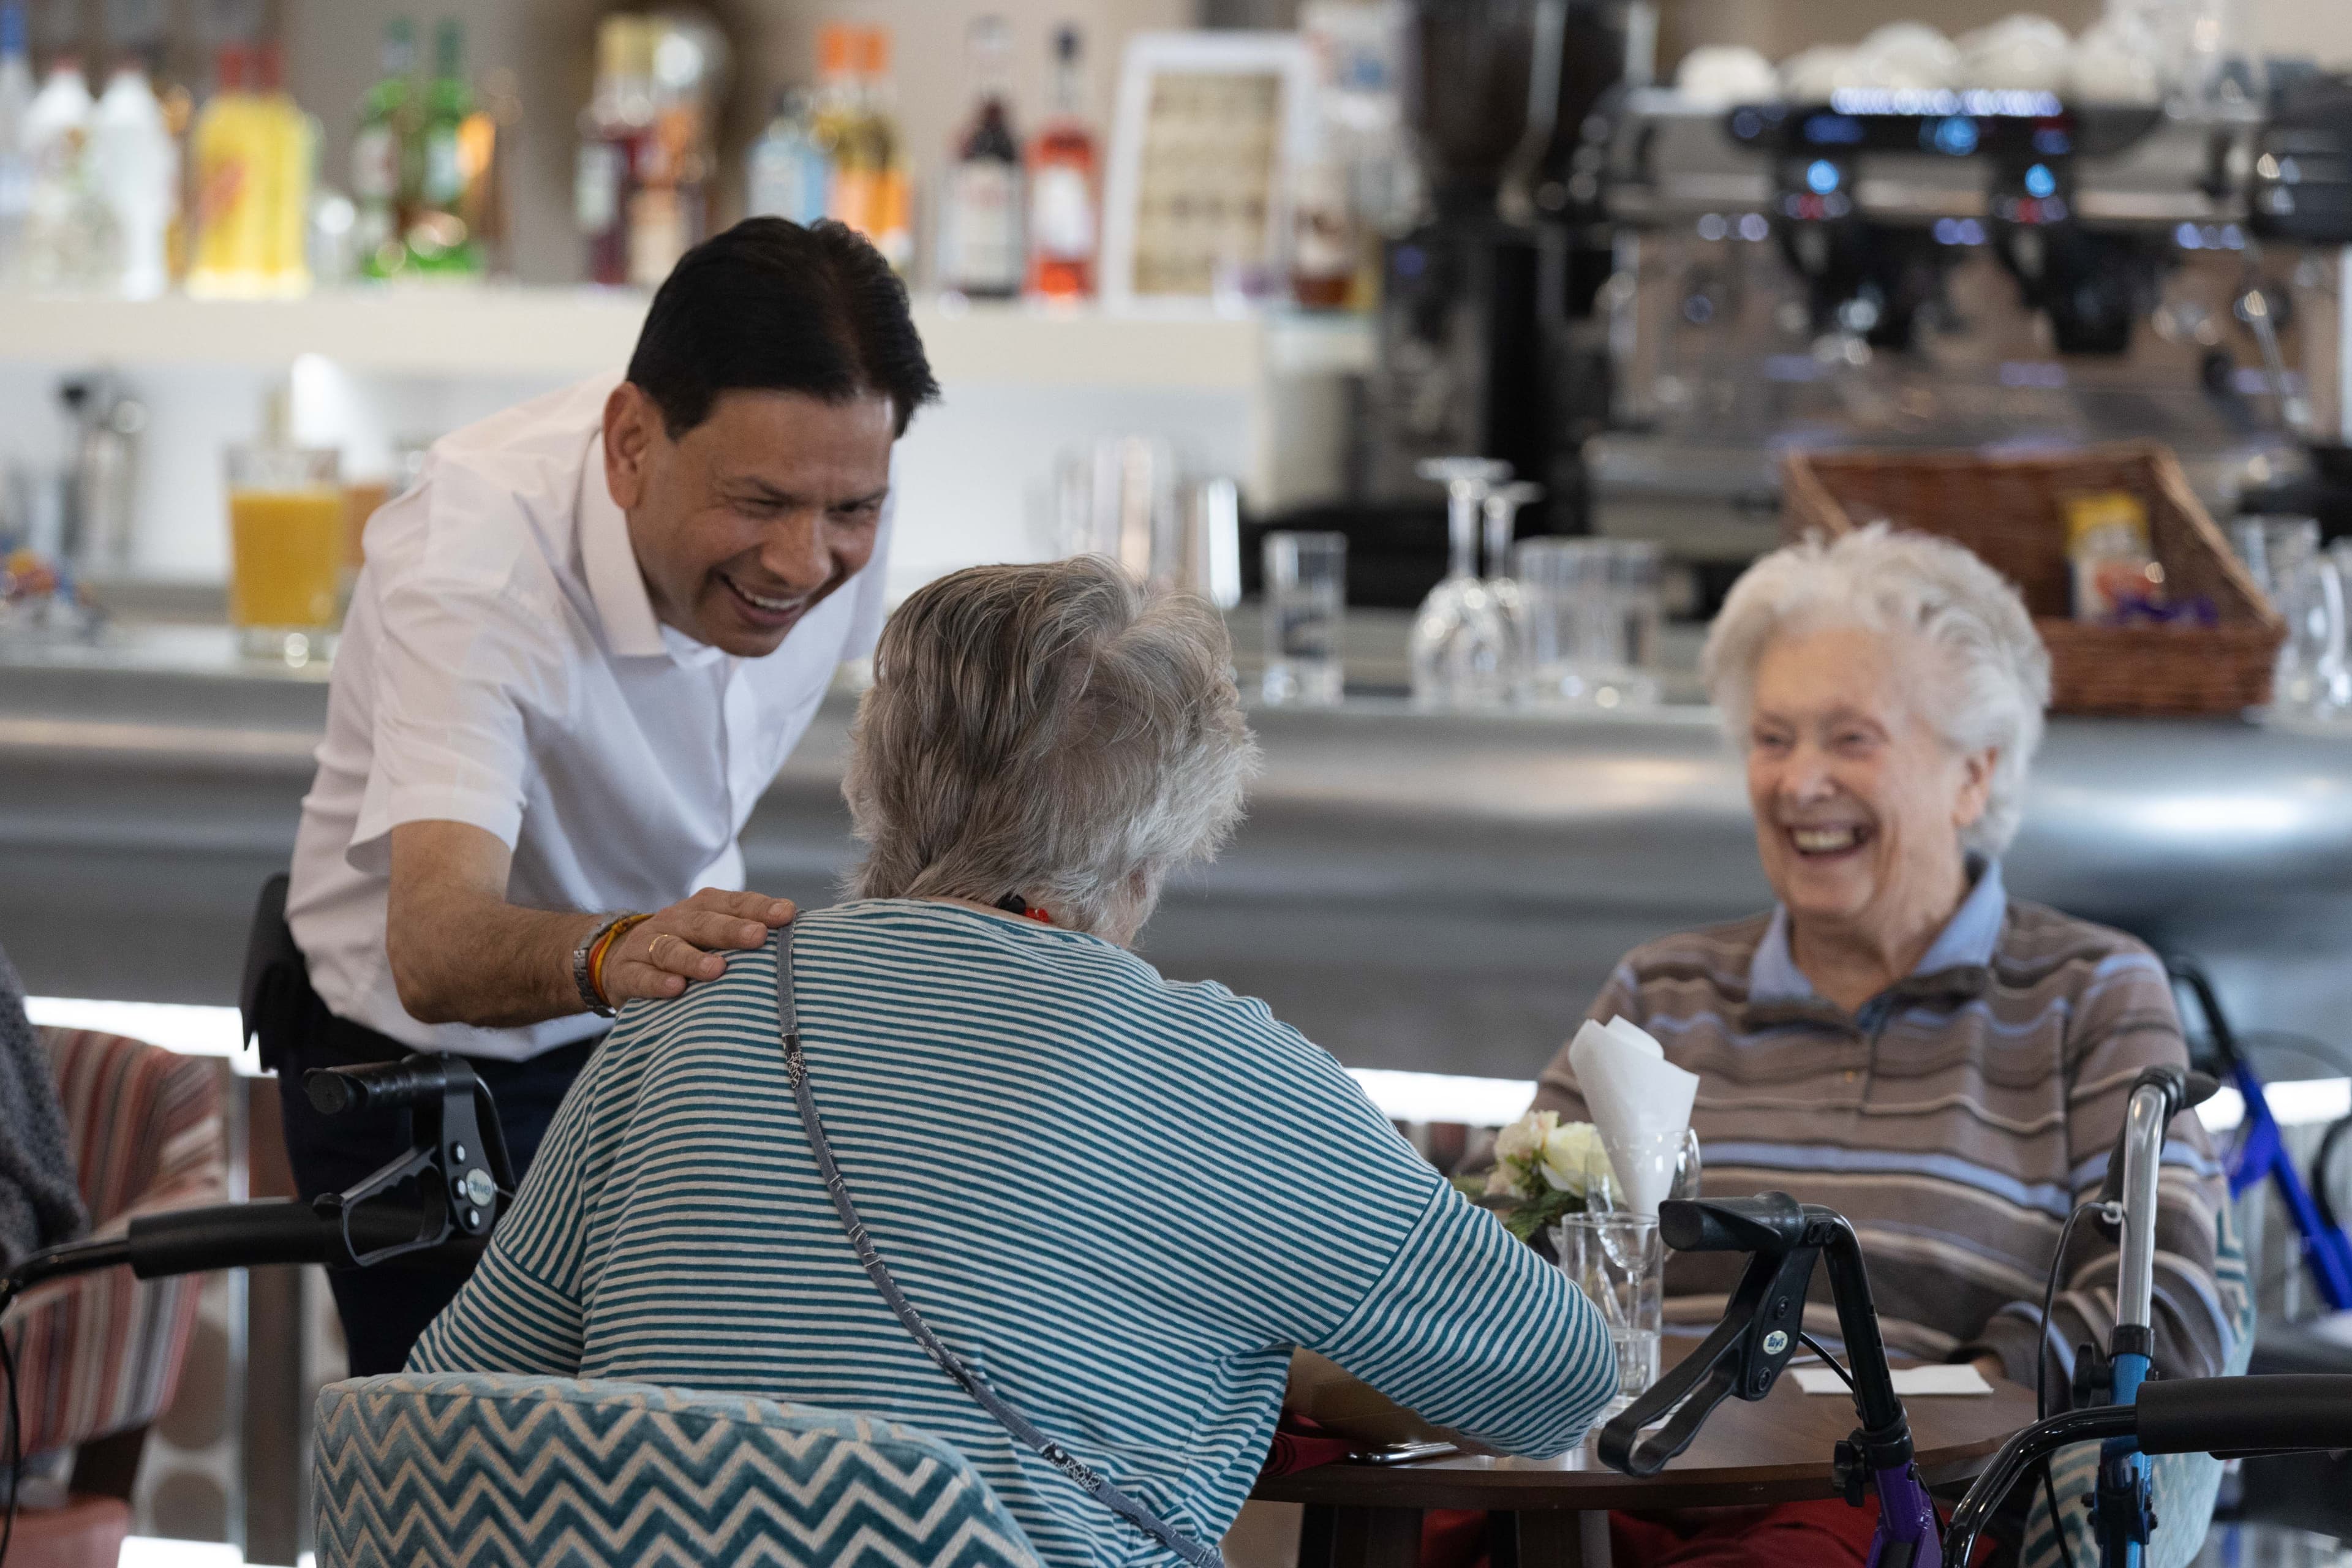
[1747, 628, 1992, 933]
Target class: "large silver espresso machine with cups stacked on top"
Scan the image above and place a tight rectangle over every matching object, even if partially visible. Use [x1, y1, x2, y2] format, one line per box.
[1585, 89, 2305, 611]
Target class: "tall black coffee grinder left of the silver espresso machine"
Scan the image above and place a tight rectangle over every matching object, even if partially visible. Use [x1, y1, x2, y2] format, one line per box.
[1308, 0, 1654, 604]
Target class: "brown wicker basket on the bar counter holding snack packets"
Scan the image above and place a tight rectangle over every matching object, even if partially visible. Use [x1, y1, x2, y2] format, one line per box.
[1781, 442, 2286, 715]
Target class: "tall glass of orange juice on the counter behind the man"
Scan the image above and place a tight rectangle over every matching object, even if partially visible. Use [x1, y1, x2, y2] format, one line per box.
[226, 447, 344, 665]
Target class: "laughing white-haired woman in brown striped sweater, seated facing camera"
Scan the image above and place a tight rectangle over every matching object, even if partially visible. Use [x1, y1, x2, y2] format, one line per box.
[1536, 527, 2244, 1568]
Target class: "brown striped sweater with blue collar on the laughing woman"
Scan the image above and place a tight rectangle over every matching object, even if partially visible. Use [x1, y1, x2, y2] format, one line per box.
[1536, 865, 2244, 1403]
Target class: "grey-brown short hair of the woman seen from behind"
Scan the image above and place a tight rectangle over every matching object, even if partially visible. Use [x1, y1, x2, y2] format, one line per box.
[842, 555, 1258, 931]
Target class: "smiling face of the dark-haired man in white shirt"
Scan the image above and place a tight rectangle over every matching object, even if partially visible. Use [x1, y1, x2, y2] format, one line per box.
[605, 383, 896, 658]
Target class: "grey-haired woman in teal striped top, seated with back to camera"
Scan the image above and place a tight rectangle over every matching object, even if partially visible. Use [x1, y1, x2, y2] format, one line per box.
[409, 557, 1616, 1568]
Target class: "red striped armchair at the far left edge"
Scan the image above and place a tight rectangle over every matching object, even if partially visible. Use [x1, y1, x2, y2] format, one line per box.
[5, 1030, 228, 1455]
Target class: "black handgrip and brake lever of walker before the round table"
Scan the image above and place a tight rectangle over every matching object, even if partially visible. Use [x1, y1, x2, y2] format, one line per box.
[1599, 1192, 1820, 1476]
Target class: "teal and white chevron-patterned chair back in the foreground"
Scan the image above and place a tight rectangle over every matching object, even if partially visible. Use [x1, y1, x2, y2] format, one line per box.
[313, 1373, 1037, 1568]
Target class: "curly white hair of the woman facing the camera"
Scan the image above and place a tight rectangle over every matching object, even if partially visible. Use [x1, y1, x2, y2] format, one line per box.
[1700, 524, 2051, 856]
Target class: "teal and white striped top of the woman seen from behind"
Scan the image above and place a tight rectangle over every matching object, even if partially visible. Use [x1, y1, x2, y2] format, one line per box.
[409, 900, 1616, 1568]
